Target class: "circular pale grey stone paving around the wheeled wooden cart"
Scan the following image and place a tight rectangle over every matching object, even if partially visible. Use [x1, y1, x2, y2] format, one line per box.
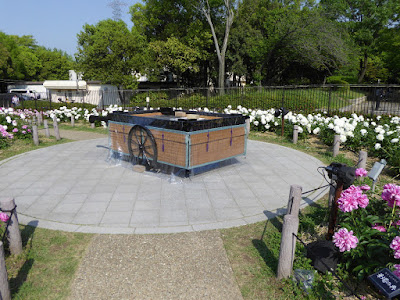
[0, 138, 327, 234]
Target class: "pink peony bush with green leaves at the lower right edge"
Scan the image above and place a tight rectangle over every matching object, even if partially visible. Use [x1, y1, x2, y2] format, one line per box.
[333, 169, 400, 280]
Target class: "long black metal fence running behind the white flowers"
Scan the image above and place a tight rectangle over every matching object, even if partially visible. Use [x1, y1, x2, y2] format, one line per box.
[0, 85, 400, 115]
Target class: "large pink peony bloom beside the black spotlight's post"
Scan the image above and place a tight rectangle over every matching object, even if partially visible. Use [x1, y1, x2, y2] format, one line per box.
[338, 185, 369, 212]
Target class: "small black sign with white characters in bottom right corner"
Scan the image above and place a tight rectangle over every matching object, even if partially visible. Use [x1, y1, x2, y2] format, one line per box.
[368, 268, 400, 299]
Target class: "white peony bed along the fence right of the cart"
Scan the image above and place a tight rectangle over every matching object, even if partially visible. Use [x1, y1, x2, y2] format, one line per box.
[225, 106, 400, 170]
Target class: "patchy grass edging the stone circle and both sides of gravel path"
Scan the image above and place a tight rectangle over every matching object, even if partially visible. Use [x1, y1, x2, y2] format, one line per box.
[0, 124, 393, 299]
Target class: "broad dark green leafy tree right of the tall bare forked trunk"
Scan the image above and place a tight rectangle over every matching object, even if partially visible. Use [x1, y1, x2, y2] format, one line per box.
[230, 0, 347, 85]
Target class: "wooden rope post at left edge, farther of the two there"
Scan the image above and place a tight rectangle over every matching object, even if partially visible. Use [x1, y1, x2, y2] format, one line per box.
[0, 198, 22, 255]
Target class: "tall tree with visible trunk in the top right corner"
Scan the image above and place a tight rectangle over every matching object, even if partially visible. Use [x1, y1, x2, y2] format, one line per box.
[321, 0, 400, 83]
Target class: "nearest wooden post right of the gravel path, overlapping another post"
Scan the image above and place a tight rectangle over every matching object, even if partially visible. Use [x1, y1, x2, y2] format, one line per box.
[277, 215, 299, 279]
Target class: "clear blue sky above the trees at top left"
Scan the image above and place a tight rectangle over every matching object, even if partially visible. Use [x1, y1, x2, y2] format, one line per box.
[0, 0, 141, 55]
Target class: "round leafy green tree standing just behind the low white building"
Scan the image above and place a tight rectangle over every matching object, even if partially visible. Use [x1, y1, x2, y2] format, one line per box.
[76, 19, 145, 101]
